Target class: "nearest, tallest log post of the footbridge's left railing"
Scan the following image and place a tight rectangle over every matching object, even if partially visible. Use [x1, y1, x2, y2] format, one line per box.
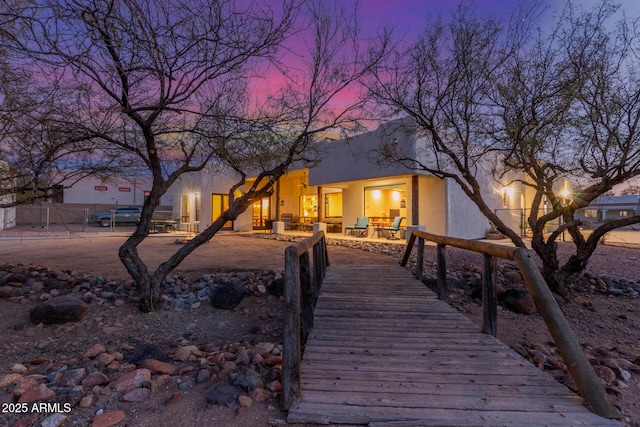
[282, 246, 301, 409]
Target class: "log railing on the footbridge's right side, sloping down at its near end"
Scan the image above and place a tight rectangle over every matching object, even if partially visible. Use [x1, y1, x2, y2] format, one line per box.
[401, 230, 620, 418]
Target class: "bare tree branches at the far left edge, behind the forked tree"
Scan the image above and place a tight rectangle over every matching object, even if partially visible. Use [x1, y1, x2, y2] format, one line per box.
[0, 8, 131, 207]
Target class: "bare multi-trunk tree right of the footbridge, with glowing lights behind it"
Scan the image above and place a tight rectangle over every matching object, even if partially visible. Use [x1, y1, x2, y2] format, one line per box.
[370, 2, 640, 296]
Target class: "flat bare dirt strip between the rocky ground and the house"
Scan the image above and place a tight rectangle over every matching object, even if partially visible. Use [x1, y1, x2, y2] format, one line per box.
[0, 232, 396, 278]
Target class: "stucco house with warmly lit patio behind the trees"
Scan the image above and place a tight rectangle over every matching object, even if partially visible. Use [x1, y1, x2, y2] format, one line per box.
[173, 120, 502, 239]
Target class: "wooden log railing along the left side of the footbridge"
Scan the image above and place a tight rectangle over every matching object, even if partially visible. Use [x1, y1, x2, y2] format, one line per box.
[282, 231, 329, 410]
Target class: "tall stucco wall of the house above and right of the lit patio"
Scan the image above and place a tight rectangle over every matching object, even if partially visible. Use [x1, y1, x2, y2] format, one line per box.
[309, 122, 491, 238]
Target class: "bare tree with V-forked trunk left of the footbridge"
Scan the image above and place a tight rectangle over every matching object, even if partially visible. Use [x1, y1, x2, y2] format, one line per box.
[3, 0, 385, 311]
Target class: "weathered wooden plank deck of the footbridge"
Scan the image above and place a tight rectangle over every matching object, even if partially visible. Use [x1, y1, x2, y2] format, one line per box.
[288, 265, 621, 426]
